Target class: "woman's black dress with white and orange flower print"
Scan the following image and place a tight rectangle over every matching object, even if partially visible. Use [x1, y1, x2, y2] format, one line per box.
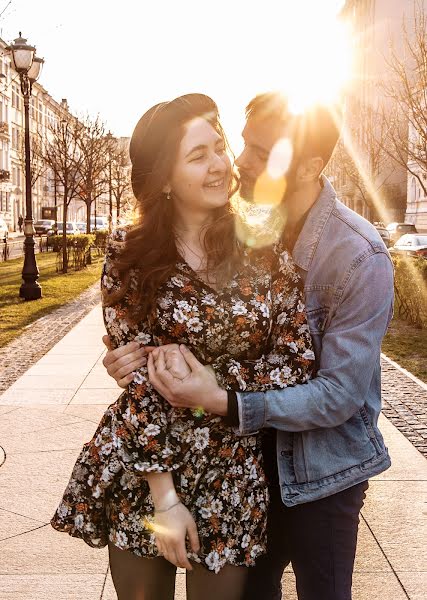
[51, 231, 314, 572]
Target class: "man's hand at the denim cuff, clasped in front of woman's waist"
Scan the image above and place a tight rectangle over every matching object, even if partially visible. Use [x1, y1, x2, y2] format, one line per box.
[147, 345, 227, 416]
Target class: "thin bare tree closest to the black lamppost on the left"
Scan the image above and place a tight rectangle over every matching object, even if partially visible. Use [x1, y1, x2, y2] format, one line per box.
[42, 114, 83, 273]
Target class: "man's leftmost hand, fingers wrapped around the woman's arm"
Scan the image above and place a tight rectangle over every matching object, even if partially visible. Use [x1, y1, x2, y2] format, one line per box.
[102, 335, 153, 388]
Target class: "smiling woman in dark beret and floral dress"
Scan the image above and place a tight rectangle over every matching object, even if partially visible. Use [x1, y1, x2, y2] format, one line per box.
[52, 94, 313, 600]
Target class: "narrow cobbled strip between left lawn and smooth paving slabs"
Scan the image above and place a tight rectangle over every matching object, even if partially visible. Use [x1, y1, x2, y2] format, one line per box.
[0, 282, 100, 393]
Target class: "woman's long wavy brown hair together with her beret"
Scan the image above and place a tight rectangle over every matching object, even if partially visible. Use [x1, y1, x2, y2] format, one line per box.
[104, 94, 239, 321]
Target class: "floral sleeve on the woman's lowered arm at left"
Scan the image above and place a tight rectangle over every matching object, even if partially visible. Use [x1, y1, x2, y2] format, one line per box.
[99, 231, 180, 473]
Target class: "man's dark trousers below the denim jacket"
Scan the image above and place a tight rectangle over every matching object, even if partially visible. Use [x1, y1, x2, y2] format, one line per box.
[243, 434, 368, 600]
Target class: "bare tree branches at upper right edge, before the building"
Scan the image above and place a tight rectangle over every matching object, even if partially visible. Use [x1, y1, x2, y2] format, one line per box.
[383, 1, 427, 195]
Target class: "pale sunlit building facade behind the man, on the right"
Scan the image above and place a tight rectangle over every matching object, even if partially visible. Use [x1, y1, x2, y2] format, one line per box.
[329, 0, 427, 223]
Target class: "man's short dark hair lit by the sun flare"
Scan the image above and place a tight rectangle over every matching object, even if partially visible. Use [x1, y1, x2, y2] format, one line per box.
[246, 92, 342, 167]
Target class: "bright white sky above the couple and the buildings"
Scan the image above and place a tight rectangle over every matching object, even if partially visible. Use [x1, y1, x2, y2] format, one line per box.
[0, 0, 347, 150]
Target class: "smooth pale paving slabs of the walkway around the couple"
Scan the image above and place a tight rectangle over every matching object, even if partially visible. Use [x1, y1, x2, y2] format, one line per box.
[0, 306, 427, 600]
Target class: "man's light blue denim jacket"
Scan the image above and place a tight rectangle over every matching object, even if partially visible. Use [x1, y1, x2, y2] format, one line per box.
[238, 177, 393, 506]
